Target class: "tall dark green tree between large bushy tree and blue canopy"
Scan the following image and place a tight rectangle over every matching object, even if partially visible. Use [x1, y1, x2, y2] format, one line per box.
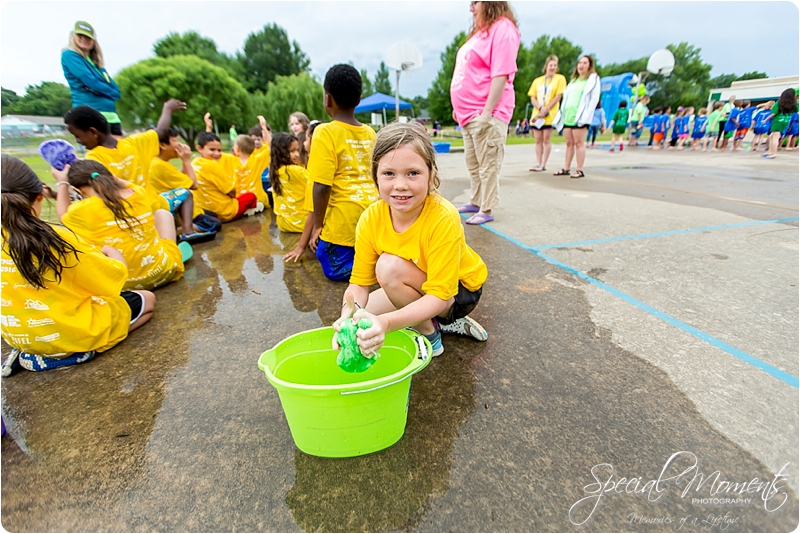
[236, 24, 310, 92]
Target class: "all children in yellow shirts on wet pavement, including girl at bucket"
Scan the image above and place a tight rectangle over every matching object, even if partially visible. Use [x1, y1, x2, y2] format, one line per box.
[2, 65, 487, 376]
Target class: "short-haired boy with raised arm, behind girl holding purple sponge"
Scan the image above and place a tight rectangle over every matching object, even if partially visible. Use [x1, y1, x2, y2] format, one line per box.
[64, 98, 186, 195]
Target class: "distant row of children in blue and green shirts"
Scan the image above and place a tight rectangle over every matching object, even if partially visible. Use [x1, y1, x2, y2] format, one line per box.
[608, 89, 798, 158]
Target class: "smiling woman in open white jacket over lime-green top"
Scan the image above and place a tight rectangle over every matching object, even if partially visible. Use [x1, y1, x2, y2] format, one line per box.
[553, 55, 600, 178]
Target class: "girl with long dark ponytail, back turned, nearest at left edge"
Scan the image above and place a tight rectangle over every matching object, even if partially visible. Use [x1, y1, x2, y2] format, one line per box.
[0, 154, 155, 376]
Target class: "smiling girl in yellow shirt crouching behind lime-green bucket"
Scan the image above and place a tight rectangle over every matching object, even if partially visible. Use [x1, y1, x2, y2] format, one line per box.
[333, 123, 488, 356]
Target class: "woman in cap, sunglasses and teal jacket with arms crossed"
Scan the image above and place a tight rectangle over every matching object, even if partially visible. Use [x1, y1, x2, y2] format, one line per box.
[61, 20, 122, 137]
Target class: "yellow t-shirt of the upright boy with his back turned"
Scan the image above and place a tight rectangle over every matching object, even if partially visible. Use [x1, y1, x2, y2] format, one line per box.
[308, 121, 378, 247]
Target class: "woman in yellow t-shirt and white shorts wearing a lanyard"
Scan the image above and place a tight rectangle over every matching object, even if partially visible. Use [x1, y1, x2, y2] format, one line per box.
[528, 55, 567, 172]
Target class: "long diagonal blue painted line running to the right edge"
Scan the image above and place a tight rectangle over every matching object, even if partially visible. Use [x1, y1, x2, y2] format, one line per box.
[466, 217, 799, 389]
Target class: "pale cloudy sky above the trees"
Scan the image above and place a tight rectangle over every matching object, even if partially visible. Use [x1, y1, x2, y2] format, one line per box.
[0, 0, 800, 97]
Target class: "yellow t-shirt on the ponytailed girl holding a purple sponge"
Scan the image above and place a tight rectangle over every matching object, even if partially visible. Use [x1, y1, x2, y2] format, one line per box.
[62, 184, 183, 290]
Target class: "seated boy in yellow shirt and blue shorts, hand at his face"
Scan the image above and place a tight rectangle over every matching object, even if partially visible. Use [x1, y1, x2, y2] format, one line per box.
[148, 128, 206, 239]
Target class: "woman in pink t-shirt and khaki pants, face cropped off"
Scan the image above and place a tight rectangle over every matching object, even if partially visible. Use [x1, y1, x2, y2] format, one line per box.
[450, 2, 519, 224]
